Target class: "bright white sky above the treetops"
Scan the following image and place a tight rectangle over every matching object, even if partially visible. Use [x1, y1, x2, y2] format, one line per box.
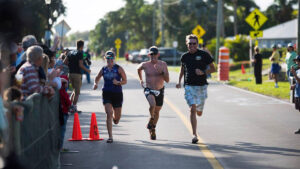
[57, 0, 274, 34]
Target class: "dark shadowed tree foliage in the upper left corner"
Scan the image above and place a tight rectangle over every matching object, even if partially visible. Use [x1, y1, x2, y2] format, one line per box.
[0, 0, 65, 42]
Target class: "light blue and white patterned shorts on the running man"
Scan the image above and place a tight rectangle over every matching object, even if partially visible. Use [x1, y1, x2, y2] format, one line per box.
[184, 85, 207, 111]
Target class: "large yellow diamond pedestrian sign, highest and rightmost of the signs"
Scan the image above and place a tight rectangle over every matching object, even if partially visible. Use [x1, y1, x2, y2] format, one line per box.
[245, 8, 268, 30]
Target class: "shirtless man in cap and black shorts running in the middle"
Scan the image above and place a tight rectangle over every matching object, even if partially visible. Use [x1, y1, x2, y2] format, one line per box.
[137, 46, 169, 140]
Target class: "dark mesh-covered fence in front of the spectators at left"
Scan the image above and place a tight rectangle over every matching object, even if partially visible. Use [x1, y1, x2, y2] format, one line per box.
[9, 92, 60, 169]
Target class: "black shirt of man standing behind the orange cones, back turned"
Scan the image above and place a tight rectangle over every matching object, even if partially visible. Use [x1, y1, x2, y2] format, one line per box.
[68, 50, 83, 74]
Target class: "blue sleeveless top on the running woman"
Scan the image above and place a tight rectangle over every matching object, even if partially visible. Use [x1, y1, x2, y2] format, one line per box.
[102, 64, 122, 93]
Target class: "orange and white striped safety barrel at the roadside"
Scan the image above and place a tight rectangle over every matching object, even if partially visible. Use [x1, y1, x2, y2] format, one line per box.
[218, 47, 229, 81]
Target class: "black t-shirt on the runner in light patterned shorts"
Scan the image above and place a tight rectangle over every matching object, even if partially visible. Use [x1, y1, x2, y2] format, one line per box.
[180, 49, 214, 86]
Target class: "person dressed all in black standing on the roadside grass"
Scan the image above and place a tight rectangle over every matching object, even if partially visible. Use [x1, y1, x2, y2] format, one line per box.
[252, 46, 262, 84]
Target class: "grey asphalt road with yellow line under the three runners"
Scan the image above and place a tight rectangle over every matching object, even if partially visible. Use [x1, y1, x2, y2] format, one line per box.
[61, 61, 300, 169]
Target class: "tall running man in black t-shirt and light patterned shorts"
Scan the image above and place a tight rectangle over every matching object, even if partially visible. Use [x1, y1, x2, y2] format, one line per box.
[176, 34, 216, 144]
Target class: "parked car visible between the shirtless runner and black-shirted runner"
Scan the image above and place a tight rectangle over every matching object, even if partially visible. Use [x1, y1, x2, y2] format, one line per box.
[158, 47, 183, 65]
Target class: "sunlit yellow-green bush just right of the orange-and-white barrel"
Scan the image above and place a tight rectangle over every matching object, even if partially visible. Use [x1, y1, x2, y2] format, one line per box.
[225, 35, 249, 61]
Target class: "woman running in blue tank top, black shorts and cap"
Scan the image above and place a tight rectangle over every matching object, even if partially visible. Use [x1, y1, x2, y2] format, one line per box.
[93, 51, 127, 143]
